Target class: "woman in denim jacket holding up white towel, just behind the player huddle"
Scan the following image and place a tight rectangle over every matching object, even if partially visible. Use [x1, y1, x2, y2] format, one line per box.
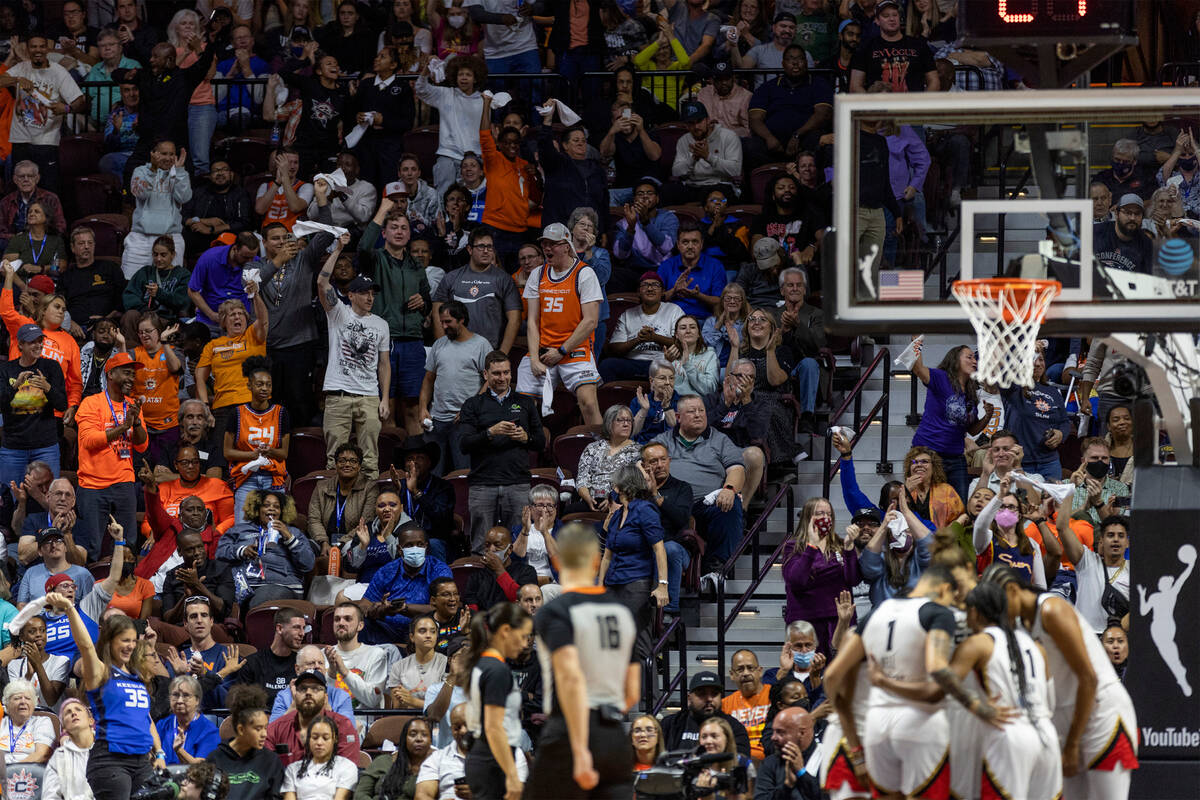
[858, 492, 931, 606]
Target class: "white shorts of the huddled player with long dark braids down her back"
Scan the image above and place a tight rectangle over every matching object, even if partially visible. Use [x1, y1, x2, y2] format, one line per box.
[979, 718, 1062, 800]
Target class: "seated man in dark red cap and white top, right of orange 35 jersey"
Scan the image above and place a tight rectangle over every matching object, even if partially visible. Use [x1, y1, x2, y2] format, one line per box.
[600, 272, 683, 381]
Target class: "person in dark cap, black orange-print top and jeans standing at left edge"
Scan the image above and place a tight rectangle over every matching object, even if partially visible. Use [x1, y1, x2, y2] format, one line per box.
[0, 323, 67, 486]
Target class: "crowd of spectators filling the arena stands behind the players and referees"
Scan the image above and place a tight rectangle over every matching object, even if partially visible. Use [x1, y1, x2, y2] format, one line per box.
[0, 0, 1161, 800]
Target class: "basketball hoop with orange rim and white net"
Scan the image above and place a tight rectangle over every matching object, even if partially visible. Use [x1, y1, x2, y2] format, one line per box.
[953, 278, 1062, 387]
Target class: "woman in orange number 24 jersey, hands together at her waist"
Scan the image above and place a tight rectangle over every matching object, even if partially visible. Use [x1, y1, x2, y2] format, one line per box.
[223, 356, 292, 522]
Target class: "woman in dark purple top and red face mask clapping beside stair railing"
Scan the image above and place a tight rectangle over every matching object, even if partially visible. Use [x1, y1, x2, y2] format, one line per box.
[784, 498, 862, 658]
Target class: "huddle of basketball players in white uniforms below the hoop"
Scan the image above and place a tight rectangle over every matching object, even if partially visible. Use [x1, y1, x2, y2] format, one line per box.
[806, 564, 1138, 800]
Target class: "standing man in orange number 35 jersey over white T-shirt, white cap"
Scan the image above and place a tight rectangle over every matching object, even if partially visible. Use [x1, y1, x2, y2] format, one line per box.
[517, 223, 604, 425]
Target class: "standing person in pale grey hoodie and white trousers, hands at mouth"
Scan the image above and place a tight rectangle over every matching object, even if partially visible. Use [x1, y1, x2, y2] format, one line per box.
[121, 139, 192, 279]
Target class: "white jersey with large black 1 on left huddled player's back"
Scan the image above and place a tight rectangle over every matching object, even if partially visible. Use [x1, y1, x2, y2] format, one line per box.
[860, 597, 953, 712]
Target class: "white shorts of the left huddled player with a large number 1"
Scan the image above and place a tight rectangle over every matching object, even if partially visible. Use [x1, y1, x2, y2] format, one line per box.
[863, 706, 950, 800]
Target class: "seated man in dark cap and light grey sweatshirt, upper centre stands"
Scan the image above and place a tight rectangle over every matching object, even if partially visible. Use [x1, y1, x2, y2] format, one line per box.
[662, 101, 742, 204]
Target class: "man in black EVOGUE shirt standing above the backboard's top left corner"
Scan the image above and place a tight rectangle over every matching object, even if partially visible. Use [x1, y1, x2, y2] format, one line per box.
[850, 0, 940, 92]
